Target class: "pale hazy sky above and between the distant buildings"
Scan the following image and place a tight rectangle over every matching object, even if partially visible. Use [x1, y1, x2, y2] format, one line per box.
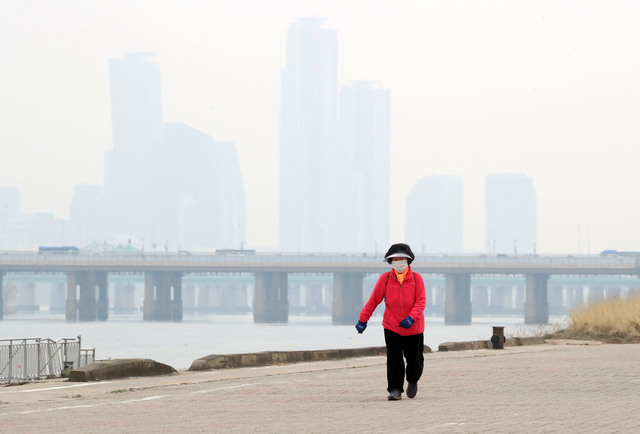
[0, 0, 640, 253]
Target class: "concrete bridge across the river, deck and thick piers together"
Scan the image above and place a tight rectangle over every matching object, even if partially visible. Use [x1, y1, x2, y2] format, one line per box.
[0, 252, 640, 324]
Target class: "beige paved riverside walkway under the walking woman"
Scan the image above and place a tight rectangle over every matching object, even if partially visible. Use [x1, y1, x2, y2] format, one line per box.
[0, 344, 640, 433]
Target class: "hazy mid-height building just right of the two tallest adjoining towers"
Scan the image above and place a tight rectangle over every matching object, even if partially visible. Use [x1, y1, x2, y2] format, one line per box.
[405, 176, 464, 253]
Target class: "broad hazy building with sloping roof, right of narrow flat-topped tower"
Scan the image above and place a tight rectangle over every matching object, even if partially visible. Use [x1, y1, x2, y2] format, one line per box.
[152, 123, 246, 249]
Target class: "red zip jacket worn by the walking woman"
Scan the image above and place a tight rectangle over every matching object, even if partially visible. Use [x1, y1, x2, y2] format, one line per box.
[360, 267, 427, 336]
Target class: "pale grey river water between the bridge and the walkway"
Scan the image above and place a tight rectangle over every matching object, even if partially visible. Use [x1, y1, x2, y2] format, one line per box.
[0, 312, 566, 369]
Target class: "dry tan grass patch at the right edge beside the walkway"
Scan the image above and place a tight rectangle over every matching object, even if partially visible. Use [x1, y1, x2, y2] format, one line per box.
[553, 295, 640, 343]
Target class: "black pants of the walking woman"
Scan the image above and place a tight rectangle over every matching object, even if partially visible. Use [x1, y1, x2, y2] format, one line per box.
[384, 329, 424, 392]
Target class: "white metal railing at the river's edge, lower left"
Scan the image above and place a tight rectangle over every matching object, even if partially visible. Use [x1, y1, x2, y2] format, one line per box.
[0, 336, 95, 383]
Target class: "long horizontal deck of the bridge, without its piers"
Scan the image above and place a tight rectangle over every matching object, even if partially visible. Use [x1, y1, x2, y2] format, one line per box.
[0, 252, 640, 274]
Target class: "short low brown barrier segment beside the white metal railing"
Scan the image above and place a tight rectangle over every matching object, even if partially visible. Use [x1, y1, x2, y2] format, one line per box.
[69, 359, 178, 382]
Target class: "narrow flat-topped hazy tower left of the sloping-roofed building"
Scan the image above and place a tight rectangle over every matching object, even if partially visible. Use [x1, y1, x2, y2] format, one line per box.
[104, 53, 163, 239]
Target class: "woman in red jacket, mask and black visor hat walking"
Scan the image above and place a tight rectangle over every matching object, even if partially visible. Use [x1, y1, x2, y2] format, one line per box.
[356, 243, 427, 401]
